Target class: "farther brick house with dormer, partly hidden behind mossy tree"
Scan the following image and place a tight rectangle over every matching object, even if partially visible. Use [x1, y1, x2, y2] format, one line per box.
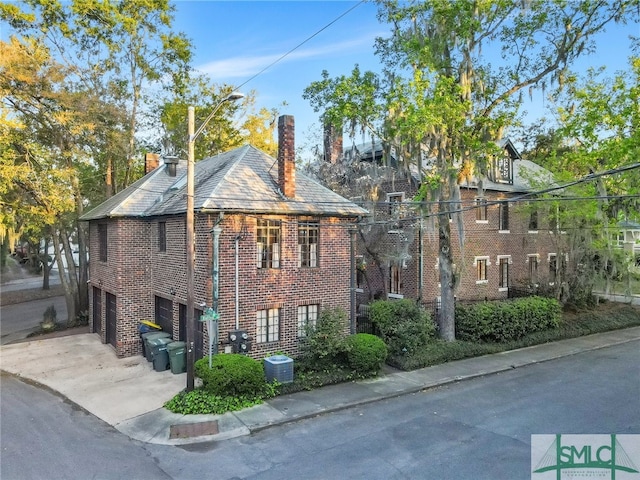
[325, 138, 564, 304]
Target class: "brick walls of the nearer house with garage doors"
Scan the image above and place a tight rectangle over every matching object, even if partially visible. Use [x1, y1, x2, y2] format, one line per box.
[90, 214, 350, 358]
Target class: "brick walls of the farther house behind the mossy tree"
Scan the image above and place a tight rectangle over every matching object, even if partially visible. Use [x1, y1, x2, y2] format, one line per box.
[358, 184, 561, 303]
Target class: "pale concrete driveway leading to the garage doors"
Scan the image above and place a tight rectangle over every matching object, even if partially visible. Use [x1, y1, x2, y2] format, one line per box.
[0, 333, 186, 427]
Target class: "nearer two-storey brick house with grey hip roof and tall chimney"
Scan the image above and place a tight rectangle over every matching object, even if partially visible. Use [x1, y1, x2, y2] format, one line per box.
[82, 116, 367, 358]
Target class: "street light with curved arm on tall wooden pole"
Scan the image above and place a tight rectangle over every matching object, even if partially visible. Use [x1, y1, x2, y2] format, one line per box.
[186, 92, 244, 392]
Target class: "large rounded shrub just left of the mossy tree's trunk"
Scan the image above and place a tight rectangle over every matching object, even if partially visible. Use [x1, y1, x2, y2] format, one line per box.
[370, 300, 436, 356]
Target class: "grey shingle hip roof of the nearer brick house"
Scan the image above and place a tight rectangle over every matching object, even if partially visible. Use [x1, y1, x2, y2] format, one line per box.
[81, 145, 368, 220]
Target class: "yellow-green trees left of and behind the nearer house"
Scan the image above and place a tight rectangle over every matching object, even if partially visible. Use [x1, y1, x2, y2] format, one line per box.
[0, 0, 284, 320]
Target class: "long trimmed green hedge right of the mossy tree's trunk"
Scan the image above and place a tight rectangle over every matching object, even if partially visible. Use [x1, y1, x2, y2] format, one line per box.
[456, 297, 562, 342]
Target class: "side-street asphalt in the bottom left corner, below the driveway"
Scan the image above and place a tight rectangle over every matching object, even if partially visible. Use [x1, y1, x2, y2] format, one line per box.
[0, 375, 171, 480]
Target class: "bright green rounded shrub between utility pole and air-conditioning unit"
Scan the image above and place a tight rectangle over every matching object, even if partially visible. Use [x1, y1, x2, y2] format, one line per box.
[195, 353, 268, 397]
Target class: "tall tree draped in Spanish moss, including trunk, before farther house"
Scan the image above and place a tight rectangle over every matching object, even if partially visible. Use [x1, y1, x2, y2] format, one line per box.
[305, 0, 638, 340]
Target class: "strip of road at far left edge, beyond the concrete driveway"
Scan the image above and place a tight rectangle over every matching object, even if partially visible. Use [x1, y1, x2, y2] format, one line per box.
[0, 297, 67, 345]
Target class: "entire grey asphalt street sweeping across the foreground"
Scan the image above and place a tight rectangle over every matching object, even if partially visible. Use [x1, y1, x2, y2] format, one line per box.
[0, 342, 640, 480]
